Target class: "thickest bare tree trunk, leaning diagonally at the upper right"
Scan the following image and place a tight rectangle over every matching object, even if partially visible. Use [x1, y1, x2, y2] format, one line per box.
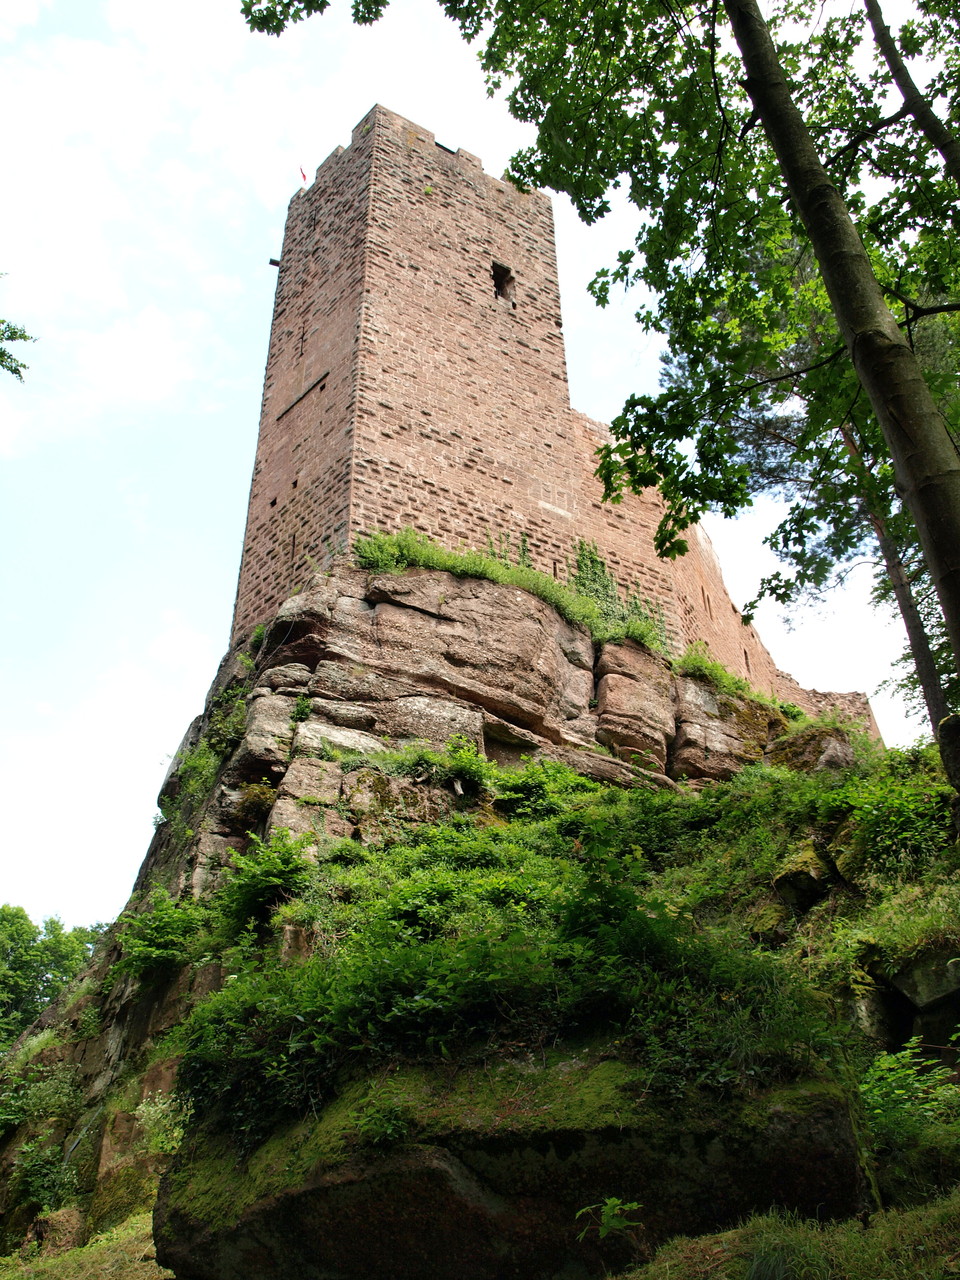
[724, 0, 960, 696]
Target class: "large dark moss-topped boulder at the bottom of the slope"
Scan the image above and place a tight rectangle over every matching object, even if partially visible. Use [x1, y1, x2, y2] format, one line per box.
[155, 1048, 864, 1280]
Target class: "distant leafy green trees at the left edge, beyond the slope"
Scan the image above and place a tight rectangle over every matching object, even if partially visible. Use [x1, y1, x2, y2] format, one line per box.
[0, 904, 102, 1052]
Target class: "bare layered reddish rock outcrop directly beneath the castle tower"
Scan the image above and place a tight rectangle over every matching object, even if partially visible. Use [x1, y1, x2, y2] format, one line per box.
[240, 566, 846, 781]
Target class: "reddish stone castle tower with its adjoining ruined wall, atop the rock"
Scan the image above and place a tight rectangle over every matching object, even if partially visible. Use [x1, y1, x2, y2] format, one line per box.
[233, 106, 796, 691]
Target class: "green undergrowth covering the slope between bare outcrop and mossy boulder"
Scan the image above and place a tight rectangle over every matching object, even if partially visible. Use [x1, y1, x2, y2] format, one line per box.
[122, 740, 960, 1172]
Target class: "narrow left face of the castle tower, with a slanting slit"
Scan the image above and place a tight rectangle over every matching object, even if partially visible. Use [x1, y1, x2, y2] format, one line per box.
[234, 138, 372, 636]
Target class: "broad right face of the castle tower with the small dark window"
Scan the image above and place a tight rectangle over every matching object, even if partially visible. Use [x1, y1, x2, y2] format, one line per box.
[353, 113, 580, 573]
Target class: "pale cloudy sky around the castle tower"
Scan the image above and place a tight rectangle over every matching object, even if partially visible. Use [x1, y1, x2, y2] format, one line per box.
[0, 0, 922, 924]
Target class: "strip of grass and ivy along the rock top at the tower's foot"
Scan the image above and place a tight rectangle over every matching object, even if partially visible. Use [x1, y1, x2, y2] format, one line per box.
[353, 529, 668, 653]
